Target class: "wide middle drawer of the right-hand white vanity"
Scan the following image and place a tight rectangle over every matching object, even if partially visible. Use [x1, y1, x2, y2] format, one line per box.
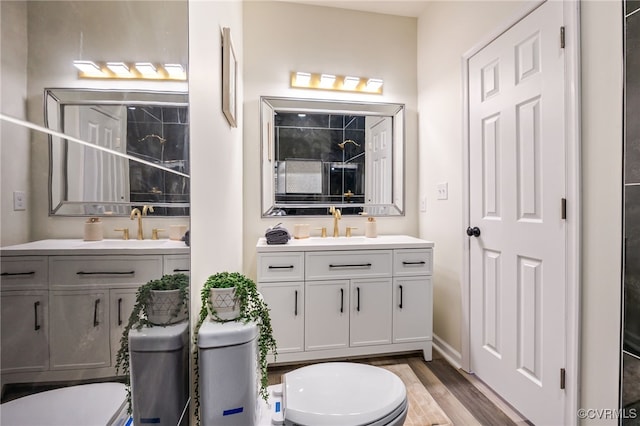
[305, 250, 392, 280]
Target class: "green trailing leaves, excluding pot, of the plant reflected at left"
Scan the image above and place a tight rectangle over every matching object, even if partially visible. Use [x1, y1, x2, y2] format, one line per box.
[115, 274, 189, 414]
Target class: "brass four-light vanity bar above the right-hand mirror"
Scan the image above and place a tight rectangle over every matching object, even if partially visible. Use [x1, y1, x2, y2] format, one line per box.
[291, 71, 384, 95]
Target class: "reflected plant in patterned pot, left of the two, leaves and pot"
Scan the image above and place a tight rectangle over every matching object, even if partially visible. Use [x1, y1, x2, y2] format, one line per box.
[115, 274, 189, 414]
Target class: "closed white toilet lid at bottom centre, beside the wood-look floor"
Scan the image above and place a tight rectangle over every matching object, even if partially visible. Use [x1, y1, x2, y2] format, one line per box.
[283, 362, 406, 426]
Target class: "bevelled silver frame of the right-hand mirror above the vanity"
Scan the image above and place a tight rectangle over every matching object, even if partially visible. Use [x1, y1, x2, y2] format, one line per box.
[260, 96, 406, 218]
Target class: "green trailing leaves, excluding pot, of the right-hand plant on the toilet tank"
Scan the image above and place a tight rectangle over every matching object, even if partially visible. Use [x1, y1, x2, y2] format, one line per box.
[193, 272, 277, 424]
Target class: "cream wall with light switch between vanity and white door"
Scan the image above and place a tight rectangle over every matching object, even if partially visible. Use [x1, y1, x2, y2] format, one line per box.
[418, 1, 523, 362]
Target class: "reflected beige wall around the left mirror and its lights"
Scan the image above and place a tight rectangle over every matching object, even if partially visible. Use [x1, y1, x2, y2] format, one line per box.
[18, 0, 188, 240]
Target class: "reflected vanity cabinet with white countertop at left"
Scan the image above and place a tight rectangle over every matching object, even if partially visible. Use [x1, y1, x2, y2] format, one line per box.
[0, 240, 189, 386]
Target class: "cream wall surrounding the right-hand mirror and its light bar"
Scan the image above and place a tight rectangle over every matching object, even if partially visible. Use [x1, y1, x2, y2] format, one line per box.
[243, 1, 418, 278]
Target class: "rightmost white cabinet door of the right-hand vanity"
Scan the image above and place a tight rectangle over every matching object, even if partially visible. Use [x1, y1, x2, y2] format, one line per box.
[393, 276, 433, 343]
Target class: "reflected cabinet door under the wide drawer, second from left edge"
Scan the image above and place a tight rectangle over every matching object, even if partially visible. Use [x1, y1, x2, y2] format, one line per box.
[50, 290, 111, 370]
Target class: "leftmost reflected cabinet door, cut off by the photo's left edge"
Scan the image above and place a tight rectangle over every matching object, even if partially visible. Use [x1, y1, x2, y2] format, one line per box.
[0, 290, 49, 373]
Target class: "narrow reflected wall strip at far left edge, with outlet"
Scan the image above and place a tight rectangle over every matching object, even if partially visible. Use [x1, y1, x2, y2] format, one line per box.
[0, 1, 30, 246]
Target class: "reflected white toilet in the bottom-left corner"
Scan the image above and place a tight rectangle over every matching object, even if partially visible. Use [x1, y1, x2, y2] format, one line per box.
[0, 383, 130, 426]
